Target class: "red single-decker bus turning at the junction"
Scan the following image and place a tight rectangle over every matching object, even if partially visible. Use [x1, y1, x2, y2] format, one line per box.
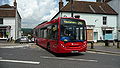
[33, 17, 87, 53]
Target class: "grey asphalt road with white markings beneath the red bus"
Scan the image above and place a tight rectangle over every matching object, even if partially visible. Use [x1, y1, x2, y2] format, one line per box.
[0, 45, 120, 68]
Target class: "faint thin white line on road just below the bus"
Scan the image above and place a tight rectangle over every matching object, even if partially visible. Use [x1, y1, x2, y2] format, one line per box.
[41, 56, 98, 62]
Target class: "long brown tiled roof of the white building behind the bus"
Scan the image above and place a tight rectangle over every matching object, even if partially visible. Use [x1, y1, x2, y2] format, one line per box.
[60, 1, 117, 15]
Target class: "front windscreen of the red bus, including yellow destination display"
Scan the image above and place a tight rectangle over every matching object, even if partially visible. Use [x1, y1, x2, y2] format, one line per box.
[60, 19, 86, 42]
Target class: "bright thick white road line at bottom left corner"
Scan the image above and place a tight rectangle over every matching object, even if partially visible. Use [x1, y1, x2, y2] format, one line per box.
[0, 59, 40, 64]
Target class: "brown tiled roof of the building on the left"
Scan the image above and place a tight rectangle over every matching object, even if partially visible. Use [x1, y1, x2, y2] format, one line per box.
[0, 4, 15, 17]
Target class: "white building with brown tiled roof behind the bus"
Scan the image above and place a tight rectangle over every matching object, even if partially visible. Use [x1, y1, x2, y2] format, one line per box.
[52, 0, 118, 41]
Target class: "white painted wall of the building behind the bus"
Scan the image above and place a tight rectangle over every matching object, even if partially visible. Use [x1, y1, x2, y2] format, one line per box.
[54, 12, 117, 41]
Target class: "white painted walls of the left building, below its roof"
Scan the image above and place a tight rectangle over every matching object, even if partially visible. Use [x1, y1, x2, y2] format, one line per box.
[3, 14, 21, 40]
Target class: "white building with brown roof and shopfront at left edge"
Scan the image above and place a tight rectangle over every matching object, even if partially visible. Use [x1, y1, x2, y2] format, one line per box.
[0, 0, 21, 40]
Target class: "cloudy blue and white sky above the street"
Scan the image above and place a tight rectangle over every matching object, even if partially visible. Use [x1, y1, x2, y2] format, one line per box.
[0, 0, 95, 28]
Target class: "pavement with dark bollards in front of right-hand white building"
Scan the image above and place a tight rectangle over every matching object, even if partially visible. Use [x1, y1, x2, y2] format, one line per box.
[88, 43, 120, 55]
